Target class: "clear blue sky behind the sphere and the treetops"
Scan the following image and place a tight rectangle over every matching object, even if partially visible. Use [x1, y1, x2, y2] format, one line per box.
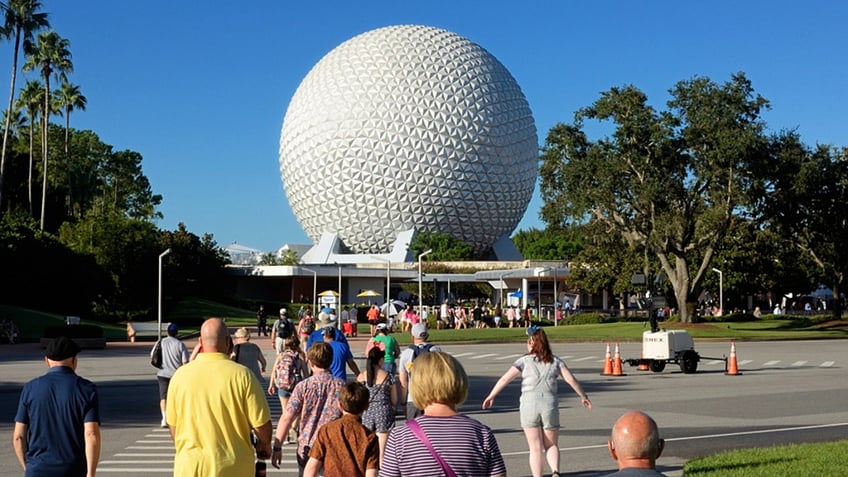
[14, 0, 848, 251]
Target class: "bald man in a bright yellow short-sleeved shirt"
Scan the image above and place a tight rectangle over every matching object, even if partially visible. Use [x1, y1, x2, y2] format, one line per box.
[167, 318, 271, 477]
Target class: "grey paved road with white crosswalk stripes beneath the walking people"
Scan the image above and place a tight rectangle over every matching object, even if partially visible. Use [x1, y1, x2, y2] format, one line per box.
[0, 338, 848, 476]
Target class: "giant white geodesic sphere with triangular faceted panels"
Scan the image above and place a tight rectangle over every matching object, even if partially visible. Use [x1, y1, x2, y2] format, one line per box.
[280, 25, 538, 253]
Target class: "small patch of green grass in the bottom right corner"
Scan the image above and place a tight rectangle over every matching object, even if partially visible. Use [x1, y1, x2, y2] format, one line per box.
[683, 440, 848, 477]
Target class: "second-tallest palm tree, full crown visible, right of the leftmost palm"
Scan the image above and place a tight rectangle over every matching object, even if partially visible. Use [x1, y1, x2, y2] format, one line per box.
[24, 30, 74, 230]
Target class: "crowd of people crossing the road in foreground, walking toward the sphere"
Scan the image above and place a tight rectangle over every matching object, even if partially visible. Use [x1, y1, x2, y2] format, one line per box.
[13, 309, 664, 477]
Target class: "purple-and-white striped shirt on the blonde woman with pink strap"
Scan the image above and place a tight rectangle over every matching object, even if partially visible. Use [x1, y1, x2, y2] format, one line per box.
[380, 415, 506, 477]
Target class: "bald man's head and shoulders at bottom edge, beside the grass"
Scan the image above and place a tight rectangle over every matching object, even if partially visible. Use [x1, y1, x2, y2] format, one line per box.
[607, 411, 665, 477]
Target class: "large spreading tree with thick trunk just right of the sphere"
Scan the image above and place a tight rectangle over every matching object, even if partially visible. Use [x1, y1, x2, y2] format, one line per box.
[540, 73, 768, 322]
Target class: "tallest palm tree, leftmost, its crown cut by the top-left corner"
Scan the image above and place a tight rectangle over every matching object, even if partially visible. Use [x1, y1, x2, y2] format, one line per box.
[0, 0, 50, 208]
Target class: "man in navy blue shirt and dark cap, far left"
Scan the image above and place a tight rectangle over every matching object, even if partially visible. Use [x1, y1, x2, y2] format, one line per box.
[12, 336, 100, 477]
